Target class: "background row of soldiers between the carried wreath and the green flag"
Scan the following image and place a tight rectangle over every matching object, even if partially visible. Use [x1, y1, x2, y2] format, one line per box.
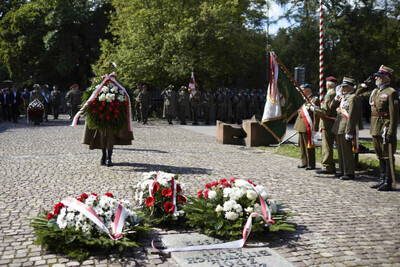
[133, 84, 266, 125]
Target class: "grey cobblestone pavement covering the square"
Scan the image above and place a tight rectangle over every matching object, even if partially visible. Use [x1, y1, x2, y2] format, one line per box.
[0, 116, 400, 267]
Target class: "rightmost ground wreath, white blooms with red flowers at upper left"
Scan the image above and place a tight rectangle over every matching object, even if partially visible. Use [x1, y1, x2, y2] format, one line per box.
[184, 178, 295, 240]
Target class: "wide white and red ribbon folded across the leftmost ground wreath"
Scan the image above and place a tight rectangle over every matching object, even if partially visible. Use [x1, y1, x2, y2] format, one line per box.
[61, 197, 127, 240]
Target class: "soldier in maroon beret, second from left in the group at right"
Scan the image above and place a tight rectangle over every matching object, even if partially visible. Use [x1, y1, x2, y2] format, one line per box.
[314, 76, 339, 174]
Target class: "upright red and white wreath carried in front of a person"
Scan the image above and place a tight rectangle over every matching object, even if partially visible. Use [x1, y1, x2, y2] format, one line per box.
[82, 79, 129, 132]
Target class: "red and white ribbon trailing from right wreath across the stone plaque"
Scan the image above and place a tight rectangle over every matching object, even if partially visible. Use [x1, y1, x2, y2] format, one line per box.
[151, 182, 275, 253]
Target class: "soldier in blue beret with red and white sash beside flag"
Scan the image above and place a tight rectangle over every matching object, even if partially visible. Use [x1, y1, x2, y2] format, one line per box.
[294, 84, 318, 170]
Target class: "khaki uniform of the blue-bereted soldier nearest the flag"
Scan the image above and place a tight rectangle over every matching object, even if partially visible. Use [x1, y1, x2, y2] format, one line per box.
[294, 94, 318, 170]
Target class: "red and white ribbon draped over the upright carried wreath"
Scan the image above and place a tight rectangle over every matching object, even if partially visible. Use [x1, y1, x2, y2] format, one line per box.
[71, 73, 132, 131]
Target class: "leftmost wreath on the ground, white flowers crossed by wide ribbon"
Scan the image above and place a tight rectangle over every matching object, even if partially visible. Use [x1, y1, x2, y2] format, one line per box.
[30, 193, 149, 261]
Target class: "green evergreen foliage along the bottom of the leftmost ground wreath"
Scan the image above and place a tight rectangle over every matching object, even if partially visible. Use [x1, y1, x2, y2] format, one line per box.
[30, 213, 150, 262]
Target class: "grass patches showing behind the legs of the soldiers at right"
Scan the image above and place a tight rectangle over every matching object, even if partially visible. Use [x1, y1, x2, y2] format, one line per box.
[260, 141, 400, 177]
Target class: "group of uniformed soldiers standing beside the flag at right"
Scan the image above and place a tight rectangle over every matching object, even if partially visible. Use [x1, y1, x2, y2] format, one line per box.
[295, 65, 399, 191]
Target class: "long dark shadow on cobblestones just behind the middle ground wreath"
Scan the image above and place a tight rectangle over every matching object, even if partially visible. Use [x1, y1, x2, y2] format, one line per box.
[114, 162, 211, 174]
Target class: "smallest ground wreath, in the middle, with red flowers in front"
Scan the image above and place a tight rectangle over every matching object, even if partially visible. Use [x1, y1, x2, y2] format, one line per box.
[133, 171, 186, 226]
